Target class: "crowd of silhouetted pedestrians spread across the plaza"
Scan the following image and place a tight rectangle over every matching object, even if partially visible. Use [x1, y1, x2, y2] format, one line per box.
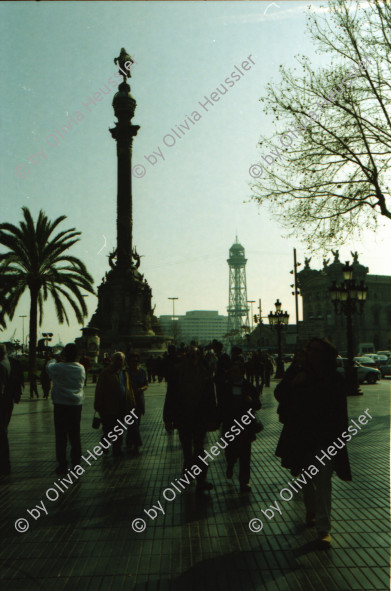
[0, 338, 351, 546]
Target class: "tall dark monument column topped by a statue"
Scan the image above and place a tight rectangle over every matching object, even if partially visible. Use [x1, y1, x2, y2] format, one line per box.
[83, 48, 165, 352]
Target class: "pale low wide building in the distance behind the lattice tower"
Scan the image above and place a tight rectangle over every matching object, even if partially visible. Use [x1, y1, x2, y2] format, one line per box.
[159, 310, 228, 345]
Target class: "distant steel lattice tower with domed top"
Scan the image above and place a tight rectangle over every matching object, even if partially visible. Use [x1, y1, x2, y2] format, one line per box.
[227, 237, 249, 341]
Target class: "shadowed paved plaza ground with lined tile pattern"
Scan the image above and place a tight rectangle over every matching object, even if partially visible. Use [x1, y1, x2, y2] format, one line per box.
[0, 380, 391, 591]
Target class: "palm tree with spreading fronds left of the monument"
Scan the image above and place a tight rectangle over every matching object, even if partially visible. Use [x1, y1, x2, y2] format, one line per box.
[0, 207, 94, 371]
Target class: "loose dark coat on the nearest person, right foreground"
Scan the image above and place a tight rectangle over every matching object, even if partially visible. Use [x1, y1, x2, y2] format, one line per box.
[274, 371, 352, 480]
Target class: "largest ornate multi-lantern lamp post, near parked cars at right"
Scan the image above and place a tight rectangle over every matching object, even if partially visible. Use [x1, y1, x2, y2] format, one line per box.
[330, 261, 368, 395]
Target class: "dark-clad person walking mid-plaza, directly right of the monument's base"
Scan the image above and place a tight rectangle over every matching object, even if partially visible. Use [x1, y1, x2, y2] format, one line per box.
[165, 345, 217, 493]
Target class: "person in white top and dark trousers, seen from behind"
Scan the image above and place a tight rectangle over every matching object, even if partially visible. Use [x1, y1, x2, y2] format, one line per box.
[46, 343, 85, 474]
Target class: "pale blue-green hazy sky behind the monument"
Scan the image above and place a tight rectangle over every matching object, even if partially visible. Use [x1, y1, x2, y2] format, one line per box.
[0, 1, 391, 343]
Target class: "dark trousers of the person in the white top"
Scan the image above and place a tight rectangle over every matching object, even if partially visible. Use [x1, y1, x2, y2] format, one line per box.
[54, 404, 82, 471]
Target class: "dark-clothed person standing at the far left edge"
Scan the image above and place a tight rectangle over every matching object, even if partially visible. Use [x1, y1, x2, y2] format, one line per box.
[0, 344, 24, 478]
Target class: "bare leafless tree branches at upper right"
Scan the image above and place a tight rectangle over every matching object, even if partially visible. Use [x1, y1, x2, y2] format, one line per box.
[250, 0, 391, 250]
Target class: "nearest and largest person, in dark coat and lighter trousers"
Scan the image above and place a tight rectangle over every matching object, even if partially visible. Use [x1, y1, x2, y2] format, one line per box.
[275, 338, 352, 546]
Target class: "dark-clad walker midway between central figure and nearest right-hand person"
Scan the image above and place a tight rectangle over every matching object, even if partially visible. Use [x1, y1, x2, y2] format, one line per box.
[218, 360, 261, 492]
